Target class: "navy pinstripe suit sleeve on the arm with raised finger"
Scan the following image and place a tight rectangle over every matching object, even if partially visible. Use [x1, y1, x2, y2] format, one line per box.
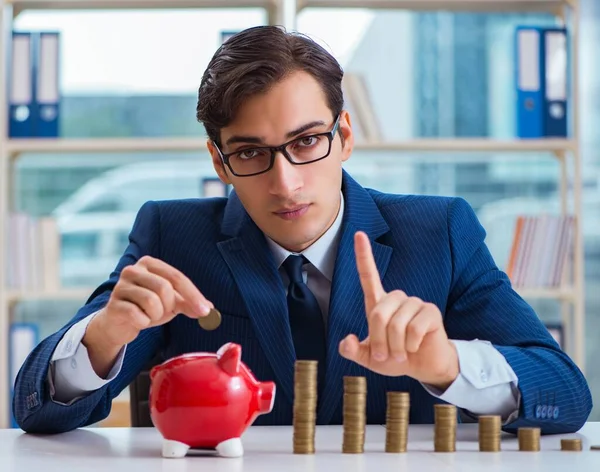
[445, 198, 592, 434]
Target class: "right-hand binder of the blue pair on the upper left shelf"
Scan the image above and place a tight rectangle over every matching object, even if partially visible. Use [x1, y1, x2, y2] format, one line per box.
[34, 32, 60, 138]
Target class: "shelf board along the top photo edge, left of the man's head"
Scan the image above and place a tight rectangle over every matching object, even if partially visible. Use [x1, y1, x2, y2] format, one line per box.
[6, 0, 277, 16]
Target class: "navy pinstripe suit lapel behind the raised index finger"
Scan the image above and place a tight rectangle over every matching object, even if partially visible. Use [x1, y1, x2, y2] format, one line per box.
[317, 172, 392, 424]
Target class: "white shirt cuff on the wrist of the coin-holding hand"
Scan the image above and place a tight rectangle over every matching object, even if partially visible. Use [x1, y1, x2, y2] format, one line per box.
[48, 312, 127, 405]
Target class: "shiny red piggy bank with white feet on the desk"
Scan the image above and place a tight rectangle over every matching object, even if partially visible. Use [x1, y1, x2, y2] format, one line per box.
[149, 343, 275, 457]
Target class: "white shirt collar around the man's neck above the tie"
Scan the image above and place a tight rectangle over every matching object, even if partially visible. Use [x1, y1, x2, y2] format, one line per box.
[267, 193, 344, 282]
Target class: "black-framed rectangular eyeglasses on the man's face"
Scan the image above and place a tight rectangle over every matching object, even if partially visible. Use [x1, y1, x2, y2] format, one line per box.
[215, 115, 340, 177]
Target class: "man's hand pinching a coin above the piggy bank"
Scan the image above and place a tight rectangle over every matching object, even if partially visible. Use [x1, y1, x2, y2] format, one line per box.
[82, 256, 213, 378]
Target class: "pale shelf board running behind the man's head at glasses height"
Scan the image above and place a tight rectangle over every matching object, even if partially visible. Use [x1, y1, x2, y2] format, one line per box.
[6, 137, 576, 157]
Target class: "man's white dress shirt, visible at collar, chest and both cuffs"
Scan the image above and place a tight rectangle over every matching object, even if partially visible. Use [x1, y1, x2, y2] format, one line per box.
[48, 195, 520, 423]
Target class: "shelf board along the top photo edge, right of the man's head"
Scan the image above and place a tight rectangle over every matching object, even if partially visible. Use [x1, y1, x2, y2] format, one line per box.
[298, 0, 578, 14]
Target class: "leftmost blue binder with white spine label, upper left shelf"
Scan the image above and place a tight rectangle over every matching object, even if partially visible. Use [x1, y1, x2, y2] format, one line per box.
[8, 32, 35, 138]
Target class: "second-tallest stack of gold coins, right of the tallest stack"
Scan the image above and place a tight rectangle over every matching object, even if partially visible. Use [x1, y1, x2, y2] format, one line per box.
[342, 376, 367, 454]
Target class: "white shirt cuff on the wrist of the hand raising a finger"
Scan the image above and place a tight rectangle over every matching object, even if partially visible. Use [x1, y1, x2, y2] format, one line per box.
[423, 339, 521, 423]
